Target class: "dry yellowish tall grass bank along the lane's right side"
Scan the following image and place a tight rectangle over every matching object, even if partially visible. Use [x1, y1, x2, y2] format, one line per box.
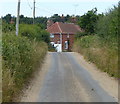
[73, 35, 118, 78]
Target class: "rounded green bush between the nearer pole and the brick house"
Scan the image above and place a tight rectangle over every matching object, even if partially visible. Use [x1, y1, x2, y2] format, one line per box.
[20, 24, 50, 43]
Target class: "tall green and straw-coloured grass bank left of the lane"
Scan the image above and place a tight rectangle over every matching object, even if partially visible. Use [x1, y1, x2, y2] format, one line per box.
[2, 33, 47, 102]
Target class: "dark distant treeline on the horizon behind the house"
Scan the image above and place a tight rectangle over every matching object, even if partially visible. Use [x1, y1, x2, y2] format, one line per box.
[2, 14, 79, 29]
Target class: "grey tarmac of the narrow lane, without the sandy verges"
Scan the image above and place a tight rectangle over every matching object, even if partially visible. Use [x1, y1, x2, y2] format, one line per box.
[37, 52, 117, 102]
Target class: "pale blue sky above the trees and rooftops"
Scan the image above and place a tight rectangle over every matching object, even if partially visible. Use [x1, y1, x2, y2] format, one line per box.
[0, 0, 118, 17]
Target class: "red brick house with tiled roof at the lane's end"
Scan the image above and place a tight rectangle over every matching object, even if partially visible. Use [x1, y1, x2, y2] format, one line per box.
[47, 22, 82, 52]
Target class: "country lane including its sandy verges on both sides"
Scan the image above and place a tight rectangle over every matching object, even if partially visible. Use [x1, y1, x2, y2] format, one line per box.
[19, 52, 118, 102]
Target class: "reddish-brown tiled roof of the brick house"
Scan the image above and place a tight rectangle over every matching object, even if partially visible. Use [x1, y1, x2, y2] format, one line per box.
[47, 22, 82, 34]
